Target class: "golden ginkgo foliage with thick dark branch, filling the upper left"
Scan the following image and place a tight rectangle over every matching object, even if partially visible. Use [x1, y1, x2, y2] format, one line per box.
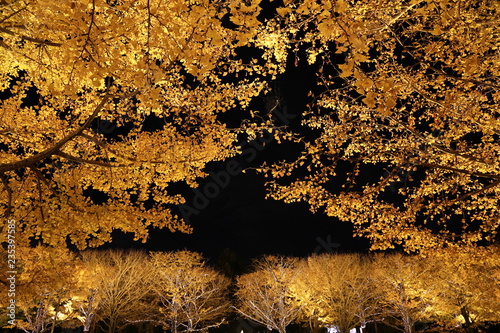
[0, 0, 283, 248]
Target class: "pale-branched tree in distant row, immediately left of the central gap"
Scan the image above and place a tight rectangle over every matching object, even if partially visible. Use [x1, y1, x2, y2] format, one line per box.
[151, 251, 230, 333]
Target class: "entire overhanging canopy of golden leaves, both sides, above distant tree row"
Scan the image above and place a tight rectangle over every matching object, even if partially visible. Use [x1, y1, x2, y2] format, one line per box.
[0, 0, 500, 250]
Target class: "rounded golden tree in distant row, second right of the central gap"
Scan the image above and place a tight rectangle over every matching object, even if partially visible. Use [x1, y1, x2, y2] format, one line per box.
[290, 253, 382, 332]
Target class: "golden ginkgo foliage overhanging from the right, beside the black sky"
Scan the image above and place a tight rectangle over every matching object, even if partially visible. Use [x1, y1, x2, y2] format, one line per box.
[264, 0, 500, 251]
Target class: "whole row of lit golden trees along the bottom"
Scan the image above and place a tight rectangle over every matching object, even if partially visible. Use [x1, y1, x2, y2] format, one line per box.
[1, 246, 500, 333]
